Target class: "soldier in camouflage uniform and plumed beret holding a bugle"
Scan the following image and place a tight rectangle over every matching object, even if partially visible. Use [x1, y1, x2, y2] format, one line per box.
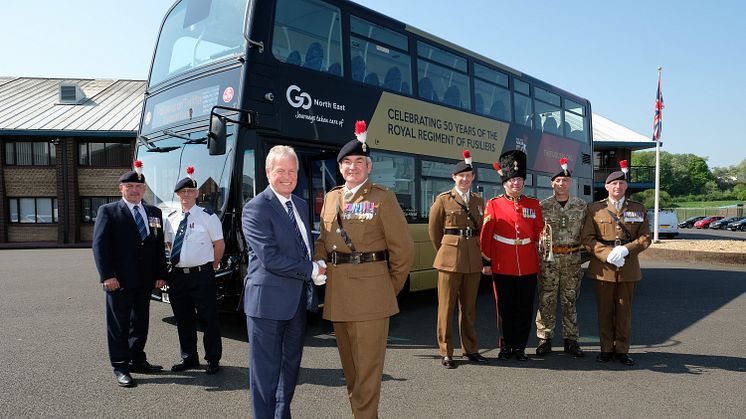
[536, 158, 587, 357]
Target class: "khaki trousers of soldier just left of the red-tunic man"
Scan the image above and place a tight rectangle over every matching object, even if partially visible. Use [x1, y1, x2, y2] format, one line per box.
[437, 271, 482, 356]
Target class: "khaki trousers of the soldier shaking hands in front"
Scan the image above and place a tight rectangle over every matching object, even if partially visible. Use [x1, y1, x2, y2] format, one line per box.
[334, 317, 389, 419]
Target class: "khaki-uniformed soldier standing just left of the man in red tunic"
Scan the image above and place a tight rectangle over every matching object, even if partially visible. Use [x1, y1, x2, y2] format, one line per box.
[428, 150, 487, 369]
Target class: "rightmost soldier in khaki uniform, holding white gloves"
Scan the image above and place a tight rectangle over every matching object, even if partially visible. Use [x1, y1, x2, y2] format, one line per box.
[580, 161, 650, 365]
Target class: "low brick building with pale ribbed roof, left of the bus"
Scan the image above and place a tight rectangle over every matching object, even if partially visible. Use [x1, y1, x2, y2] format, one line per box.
[0, 77, 145, 247]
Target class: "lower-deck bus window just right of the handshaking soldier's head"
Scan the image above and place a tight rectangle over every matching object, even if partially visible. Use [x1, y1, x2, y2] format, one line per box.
[370, 151, 417, 221]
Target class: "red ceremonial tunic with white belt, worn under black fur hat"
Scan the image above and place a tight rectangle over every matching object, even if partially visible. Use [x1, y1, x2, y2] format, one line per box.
[479, 195, 544, 276]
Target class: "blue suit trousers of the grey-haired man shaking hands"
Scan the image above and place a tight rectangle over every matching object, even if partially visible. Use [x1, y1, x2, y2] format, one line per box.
[246, 298, 306, 419]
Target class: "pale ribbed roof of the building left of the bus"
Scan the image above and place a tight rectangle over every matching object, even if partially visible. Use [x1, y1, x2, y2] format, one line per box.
[0, 76, 145, 135]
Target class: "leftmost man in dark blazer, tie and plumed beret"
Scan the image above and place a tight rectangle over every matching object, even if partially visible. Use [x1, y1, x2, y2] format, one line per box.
[93, 160, 167, 387]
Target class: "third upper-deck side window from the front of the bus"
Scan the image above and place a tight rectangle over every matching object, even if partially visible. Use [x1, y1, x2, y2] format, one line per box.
[417, 42, 471, 109]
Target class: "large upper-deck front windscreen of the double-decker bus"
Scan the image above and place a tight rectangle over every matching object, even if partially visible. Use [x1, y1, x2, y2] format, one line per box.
[150, 0, 248, 86]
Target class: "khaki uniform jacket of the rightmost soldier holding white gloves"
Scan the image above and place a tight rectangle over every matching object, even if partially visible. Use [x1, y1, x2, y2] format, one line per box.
[580, 199, 650, 282]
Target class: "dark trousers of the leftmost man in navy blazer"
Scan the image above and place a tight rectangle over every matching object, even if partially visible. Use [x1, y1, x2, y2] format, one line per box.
[106, 288, 151, 372]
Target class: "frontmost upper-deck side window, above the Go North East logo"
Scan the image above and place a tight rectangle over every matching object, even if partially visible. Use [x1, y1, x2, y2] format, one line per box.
[272, 0, 344, 76]
